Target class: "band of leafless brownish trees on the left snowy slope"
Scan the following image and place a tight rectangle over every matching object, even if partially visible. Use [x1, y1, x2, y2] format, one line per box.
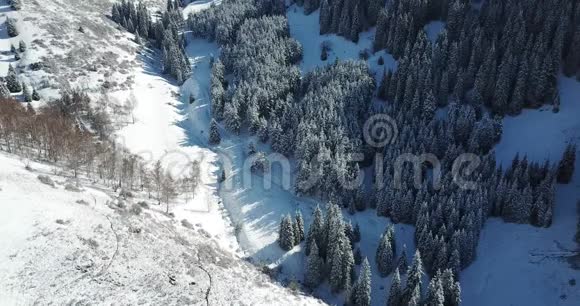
[0, 90, 200, 212]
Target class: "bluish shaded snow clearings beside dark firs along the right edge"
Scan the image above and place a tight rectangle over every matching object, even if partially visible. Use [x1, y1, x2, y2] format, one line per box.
[461, 77, 580, 306]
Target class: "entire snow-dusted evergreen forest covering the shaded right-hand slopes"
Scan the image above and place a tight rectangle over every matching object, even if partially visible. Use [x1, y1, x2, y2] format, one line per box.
[198, 0, 576, 296]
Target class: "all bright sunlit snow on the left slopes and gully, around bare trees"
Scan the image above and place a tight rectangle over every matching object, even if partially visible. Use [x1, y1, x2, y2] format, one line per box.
[0, 0, 321, 305]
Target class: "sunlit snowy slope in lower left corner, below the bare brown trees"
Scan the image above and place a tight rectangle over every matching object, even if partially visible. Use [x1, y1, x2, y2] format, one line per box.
[0, 153, 320, 305]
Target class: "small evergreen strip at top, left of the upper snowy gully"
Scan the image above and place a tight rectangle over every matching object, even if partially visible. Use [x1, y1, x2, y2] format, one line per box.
[111, 0, 191, 83]
